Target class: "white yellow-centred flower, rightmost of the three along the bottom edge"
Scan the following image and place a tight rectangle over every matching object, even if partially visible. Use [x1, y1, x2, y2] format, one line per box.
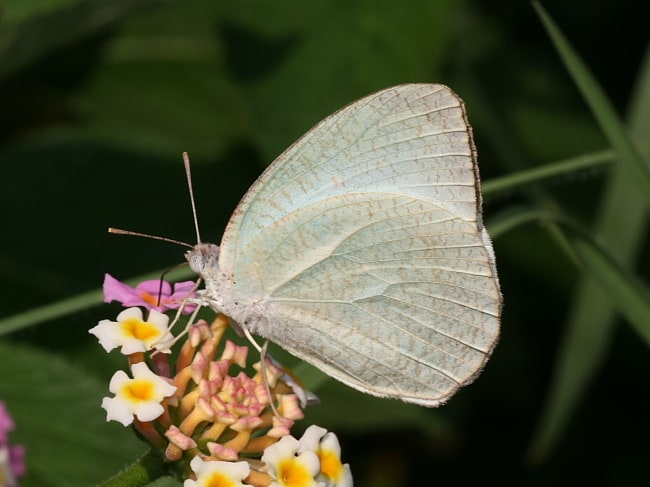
[298, 425, 352, 487]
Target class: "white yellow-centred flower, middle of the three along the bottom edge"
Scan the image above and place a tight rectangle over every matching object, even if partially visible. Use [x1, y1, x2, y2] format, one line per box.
[262, 436, 320, 487]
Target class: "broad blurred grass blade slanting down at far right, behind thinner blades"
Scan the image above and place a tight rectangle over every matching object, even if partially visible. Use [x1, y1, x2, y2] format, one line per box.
[528, 12, 650, 463]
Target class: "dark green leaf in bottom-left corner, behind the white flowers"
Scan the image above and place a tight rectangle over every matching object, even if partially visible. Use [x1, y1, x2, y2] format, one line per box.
[0, 342, 145, 487]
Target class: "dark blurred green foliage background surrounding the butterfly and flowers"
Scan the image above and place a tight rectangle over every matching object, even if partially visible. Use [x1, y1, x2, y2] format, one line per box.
[0, 0, 650, 487]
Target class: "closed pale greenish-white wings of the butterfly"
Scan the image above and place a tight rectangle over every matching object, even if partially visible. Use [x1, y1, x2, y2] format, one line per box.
[210, 84, 501, 406]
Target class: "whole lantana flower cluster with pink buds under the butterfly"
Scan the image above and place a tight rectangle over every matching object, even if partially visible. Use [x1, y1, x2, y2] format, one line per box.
[90, 274, 352, 487]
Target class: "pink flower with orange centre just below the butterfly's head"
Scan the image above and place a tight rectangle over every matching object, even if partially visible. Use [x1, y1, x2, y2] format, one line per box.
[104, 274, 196, 314]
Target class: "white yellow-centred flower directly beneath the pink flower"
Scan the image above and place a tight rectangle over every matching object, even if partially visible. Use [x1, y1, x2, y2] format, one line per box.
[89, 308, 173, 355]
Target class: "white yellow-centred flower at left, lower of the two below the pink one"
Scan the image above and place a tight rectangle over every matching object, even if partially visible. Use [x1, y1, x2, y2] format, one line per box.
[102, 362, 176, 426]
